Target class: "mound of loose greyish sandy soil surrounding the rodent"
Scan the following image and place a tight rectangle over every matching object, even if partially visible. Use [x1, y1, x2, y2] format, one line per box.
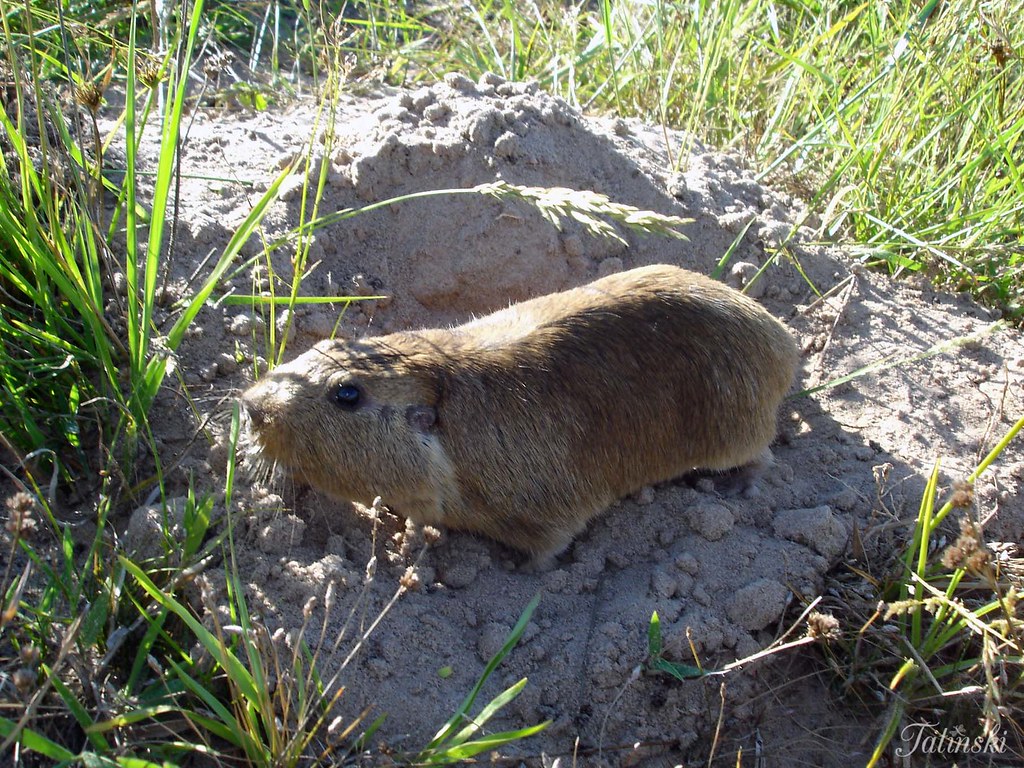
[114, 76, 1024, 766]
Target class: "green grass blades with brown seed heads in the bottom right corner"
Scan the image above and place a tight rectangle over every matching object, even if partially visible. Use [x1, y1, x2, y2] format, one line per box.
[868, 418, 1024, 768]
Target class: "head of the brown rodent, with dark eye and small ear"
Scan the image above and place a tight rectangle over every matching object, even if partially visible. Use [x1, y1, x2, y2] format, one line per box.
[242, 335, 450, 507]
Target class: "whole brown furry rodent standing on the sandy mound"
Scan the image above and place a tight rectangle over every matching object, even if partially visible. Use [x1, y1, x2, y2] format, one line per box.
[242, 265, 798, 565]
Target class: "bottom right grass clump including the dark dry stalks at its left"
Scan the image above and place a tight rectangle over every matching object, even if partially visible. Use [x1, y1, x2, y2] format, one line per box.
[798, 419, 1024, 766]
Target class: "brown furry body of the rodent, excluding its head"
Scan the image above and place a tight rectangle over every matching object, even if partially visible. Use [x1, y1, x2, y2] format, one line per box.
[432, 265, 798, 552]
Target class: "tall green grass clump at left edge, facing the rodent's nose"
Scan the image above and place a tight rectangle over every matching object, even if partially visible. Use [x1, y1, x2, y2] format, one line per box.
[0, 2, 287, 475]
